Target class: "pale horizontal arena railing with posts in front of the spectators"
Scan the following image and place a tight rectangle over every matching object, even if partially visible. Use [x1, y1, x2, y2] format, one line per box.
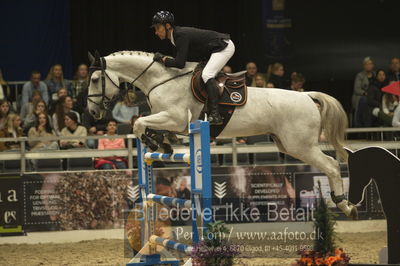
[0, 128, 400, 173]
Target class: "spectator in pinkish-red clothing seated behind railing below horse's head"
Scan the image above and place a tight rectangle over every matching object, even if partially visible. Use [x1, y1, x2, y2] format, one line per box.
[95, 120, 127, 169]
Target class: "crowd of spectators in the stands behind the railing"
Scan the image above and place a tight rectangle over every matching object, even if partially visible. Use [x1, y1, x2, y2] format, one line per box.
[0, 57, 400, 166]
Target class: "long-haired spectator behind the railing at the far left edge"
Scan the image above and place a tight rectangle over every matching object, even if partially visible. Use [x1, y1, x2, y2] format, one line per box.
[0, 114, 22, 151]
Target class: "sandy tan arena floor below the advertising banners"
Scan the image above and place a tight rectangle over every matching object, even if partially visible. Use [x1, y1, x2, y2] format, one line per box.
[0, 232, 386, 266]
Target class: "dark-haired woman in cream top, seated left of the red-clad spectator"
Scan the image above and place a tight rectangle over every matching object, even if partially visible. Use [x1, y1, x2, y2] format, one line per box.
[60, 112, 87, 149]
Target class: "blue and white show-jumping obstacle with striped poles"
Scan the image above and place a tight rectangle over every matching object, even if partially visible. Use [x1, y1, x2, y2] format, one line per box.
[127, 121, 212, 266]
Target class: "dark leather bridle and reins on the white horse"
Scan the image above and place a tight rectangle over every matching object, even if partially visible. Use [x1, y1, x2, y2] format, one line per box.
[87, 57, 193, 110]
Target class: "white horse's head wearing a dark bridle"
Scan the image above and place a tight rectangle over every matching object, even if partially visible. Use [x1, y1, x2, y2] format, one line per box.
[87, 51, 120, 119]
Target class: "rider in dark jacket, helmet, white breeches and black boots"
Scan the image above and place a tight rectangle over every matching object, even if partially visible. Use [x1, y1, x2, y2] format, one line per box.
[152, 11, 235, 125]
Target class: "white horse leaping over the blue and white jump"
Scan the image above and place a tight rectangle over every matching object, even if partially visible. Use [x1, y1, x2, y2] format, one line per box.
[88, 51, 357, 218]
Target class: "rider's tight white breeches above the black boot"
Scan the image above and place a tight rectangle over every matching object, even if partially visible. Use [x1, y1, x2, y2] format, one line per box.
[201, 40, 235, 83]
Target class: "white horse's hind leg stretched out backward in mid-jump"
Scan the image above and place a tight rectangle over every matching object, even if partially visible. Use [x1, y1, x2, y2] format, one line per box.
[293, 145, 357, 219]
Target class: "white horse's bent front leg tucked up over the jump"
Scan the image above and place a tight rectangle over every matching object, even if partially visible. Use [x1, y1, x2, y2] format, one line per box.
[133, 111, 186, 153]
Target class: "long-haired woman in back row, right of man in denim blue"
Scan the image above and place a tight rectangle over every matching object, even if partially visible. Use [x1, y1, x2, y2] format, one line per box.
[45, 64, 75, 102]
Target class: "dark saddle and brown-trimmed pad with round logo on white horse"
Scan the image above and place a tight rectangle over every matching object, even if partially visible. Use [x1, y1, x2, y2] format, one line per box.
[191, 63, 247, 106]
